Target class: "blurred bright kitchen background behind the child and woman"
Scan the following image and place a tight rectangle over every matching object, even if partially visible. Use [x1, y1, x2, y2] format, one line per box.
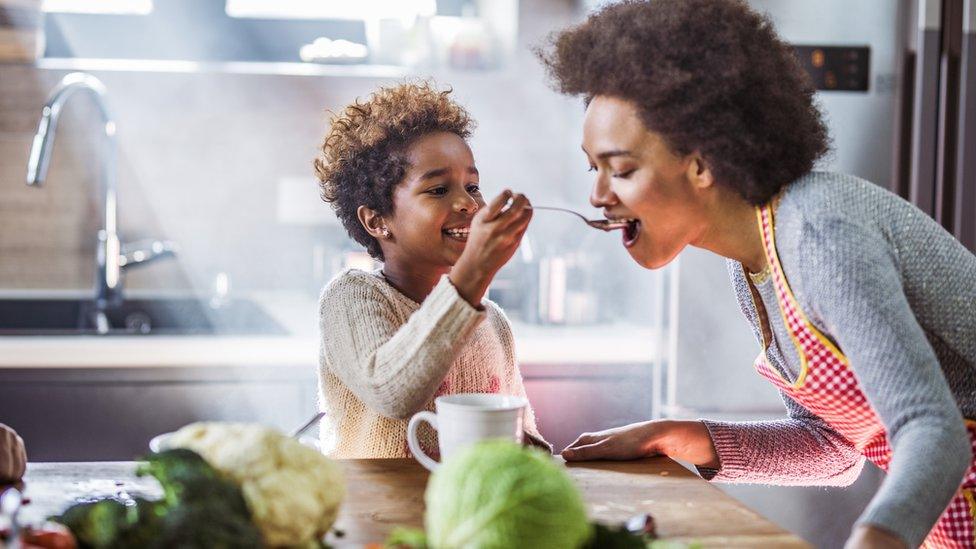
[0, 0, 976, 547]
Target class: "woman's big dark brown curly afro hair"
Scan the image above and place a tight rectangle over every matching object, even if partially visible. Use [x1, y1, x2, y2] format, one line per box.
[537, 0, 829, 205]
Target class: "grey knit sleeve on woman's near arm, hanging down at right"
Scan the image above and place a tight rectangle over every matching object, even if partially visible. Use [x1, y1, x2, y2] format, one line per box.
[797, 219, 972, 547]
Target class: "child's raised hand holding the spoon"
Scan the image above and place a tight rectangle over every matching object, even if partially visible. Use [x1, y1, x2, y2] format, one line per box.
[448, 189, 532, 307]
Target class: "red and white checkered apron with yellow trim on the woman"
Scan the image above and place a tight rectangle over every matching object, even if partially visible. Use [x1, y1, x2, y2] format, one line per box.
[750, 203, 976, 548]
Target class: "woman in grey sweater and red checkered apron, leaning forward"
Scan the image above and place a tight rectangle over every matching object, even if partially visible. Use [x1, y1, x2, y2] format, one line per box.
[540, 0, 976, 547]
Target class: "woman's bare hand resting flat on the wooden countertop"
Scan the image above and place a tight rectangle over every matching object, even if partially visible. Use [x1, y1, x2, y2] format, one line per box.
[562, 420, 719, 468]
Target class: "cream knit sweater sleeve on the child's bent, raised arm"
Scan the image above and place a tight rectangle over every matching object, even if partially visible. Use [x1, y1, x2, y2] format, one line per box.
[319, 273, 485, 419]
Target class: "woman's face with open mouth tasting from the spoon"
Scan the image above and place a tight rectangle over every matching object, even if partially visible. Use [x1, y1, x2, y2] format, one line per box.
[583, 96, 708, 269]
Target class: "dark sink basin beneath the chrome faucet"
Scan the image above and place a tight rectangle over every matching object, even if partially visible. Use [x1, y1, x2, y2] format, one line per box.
[0, 297, 287, 336]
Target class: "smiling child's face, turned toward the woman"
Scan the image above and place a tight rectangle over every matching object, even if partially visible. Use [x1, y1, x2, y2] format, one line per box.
[383, 132, 485, 270]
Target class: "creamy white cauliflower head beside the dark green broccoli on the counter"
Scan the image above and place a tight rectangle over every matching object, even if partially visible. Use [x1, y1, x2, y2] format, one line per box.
[167, 422, 346, 546]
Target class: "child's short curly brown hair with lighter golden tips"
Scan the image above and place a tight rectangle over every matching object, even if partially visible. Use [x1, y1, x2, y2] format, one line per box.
[314, 82, 475, 261]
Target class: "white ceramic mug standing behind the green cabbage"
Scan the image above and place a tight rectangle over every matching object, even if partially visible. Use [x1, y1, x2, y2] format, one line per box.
[407, 393, 528, 471]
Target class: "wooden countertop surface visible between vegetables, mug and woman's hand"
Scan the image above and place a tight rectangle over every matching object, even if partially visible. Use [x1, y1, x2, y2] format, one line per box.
[21, 457, 810, 548]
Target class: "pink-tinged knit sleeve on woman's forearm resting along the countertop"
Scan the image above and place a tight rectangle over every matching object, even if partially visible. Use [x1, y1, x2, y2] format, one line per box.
[700, 393, 864, 486]
